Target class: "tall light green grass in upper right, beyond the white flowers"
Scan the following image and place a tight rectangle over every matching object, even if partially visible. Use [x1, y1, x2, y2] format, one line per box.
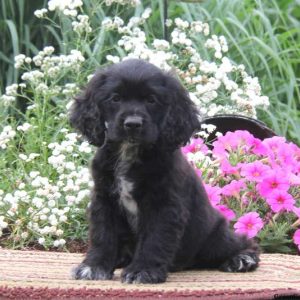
[176, 0, 300, 144]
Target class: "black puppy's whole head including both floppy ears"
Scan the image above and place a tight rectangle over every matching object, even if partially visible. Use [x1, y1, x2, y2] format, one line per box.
[70, 59, 199, 149]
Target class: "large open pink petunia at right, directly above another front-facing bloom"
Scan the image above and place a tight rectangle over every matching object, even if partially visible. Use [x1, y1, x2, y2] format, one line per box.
[256, 170, 290, 197]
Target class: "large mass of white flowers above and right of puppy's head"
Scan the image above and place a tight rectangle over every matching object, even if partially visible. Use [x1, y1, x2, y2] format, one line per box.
[103, 10, 269, 117]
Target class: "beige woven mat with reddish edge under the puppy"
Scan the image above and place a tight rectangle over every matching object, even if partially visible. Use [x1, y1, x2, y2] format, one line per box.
[0, 249, 300, 299]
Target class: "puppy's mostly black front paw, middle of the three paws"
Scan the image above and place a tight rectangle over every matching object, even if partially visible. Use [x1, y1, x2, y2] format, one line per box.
[121, 267, 167, 283]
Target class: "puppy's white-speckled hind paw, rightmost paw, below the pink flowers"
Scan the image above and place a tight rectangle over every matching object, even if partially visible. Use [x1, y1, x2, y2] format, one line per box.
[220, 253, 259, 272]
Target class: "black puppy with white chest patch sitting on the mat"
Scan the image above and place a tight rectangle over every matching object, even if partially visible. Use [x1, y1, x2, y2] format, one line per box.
[70, 59, 259, 283]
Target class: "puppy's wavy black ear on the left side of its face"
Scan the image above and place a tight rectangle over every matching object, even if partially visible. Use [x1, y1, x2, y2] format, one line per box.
[70, 72, 106, 147]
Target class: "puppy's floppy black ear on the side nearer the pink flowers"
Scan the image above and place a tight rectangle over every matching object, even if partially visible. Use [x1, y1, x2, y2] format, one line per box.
[160, 76, 200, 149]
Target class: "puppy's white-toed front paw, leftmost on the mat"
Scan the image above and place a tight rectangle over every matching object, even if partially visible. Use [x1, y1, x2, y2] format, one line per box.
[72, 263, 113, 280]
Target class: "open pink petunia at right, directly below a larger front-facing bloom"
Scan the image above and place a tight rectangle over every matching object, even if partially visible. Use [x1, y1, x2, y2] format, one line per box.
[266, 190, 295, 213]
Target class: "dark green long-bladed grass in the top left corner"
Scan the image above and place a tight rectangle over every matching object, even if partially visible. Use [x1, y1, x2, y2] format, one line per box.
[0, 0, 53, 93]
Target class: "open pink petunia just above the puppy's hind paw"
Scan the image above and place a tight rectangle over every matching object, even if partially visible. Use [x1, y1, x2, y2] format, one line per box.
[233, 212, 264, 238]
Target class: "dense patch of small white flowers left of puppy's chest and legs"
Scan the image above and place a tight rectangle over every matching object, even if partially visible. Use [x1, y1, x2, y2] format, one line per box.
[0, 124, 93, 247]
